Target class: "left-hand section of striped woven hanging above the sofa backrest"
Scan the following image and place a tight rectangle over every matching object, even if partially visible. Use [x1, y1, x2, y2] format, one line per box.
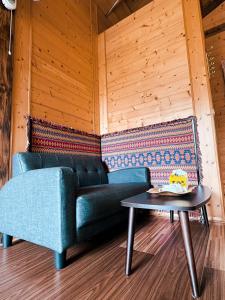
[27, 117, 101, 156]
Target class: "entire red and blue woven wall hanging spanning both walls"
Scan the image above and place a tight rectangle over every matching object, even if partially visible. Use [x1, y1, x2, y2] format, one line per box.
[28, 117, 202, 185]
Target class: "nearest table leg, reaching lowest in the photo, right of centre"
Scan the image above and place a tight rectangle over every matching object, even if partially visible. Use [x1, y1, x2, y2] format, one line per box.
[179, 211, 200, 298]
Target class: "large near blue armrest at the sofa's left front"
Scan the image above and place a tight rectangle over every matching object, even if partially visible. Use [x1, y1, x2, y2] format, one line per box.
[0, 167, 75, 253]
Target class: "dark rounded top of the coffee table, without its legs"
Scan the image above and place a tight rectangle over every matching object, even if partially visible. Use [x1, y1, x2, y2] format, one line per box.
[121, 185, 212, 211]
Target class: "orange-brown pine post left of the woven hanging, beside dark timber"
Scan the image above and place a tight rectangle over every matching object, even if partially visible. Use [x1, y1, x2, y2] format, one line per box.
[11, 0, 32, 154]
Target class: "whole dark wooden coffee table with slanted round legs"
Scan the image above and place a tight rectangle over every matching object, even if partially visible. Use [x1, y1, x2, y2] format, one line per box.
[121, 185, 211, 298]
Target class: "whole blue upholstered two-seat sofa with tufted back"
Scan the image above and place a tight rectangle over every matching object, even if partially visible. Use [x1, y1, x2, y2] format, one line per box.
[0, 153, 150, 269]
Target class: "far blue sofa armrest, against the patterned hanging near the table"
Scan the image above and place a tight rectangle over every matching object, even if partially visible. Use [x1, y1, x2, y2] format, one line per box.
[108, 167, 150, 184]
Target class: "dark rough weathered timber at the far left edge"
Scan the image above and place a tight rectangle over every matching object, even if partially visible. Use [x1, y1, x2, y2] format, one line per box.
[0, 5, 12, 187]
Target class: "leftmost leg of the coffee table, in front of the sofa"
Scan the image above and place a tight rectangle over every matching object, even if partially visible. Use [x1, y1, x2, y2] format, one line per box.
[125, 207, 134, 276]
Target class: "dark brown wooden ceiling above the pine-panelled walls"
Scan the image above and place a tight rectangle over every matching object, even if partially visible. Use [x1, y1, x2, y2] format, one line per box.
[95, 0, 224, 33]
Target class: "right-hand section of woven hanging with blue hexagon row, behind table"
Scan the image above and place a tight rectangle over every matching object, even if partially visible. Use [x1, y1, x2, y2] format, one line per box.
[101, 117, 201, 185]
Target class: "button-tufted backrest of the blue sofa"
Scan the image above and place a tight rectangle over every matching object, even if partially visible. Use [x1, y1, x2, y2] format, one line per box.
[13, 152, 108, 186]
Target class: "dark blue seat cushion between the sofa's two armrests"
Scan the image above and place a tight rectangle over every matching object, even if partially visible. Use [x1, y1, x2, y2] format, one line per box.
[76, 183, 149, 229]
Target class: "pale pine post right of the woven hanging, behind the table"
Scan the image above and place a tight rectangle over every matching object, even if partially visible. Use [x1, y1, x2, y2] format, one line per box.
[183, 0, 224, 219]
